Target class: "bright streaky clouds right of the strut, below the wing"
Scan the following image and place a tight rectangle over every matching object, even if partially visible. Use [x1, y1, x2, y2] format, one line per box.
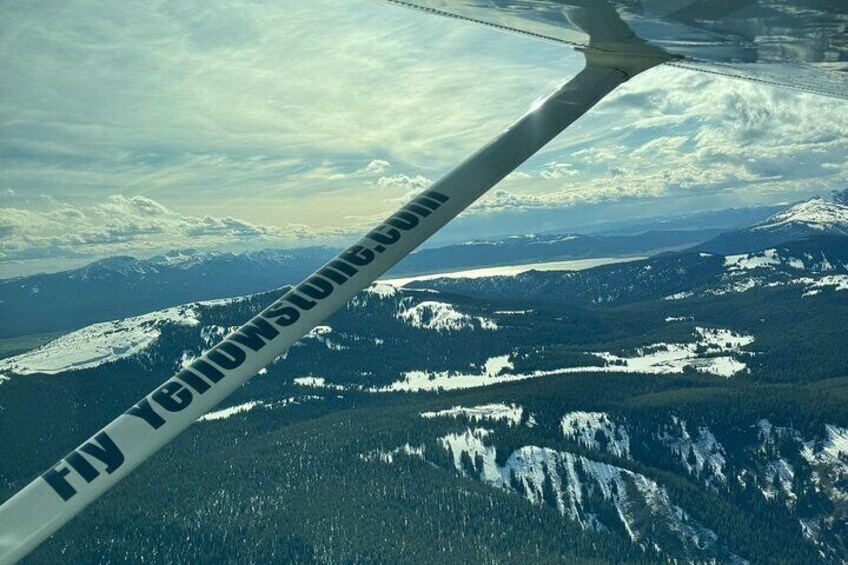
[464, 64, 848, 215]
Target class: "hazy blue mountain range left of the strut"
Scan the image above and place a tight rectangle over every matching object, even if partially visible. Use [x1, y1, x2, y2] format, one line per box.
[0, 247, 335, 338]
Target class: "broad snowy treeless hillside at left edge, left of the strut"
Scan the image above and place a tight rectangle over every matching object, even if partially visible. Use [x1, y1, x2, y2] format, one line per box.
[0, 303, 200, 375]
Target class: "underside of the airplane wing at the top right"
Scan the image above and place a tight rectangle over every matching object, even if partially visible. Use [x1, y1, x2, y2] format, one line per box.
[383, 0, 848, 99]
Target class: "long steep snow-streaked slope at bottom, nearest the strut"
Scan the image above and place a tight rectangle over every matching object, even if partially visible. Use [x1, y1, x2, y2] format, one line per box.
[374, 426, 744, 563]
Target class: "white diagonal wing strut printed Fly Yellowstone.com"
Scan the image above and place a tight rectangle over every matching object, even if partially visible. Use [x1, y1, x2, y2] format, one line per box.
[0, 53, 662, 564]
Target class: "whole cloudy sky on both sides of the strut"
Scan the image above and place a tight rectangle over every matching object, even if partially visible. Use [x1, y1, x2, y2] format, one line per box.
[0, 0, 848, 277]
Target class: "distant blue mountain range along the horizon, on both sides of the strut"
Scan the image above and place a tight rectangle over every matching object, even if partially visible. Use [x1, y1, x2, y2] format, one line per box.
[0, 194, 848, 338]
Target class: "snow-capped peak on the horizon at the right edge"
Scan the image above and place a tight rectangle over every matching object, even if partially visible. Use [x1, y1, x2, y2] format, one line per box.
[697, 193, 848, 253]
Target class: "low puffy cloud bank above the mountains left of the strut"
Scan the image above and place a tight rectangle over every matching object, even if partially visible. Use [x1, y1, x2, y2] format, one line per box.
[0, 195, 331, 268]
